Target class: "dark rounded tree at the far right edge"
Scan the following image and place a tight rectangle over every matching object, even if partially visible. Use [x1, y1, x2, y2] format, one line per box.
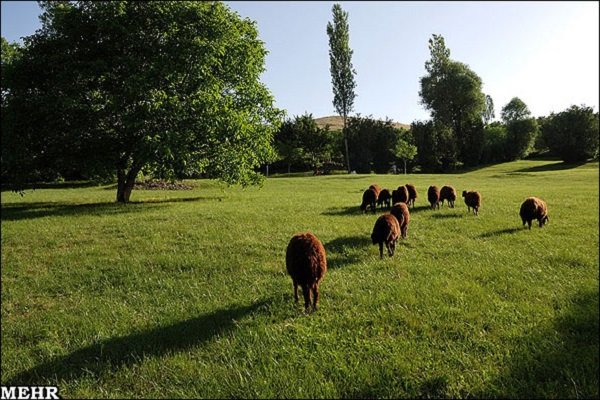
[542, 105, 599, 162]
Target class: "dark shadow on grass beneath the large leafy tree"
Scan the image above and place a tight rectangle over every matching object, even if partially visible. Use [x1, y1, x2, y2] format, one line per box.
[0, 197, 220, 221]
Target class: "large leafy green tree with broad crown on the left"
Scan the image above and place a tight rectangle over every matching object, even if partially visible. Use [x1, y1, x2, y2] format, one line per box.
[2, 1, 281, 202]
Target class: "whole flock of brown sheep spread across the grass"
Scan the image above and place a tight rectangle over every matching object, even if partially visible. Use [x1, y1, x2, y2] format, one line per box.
[285, 184, 549, 312]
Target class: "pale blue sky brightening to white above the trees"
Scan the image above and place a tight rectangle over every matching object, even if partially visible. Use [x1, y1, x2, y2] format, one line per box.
[1, 1, 600, 124]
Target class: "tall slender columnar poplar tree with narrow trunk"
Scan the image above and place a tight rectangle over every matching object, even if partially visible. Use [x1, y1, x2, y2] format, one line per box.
[327, 4, 356, 173]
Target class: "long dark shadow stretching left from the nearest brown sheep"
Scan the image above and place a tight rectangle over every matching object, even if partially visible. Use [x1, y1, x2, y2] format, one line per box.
[6, 300, 271, 385]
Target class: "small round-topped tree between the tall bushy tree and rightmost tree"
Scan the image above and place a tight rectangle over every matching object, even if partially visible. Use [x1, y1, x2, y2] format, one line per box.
[501, 97, 538, 160]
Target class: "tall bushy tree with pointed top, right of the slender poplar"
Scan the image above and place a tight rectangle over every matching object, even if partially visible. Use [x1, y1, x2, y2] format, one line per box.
[419, 34, 486, 164]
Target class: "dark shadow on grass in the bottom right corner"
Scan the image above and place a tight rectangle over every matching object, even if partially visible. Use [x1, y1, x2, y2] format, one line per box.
[474, 287, 600, 398]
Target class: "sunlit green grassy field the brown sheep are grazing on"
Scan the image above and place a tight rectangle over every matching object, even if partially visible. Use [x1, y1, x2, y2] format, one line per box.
[1, 161, 599, 398]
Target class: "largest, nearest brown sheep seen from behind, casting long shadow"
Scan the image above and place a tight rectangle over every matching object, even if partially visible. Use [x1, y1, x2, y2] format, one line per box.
[285, 232, 327, 312]
